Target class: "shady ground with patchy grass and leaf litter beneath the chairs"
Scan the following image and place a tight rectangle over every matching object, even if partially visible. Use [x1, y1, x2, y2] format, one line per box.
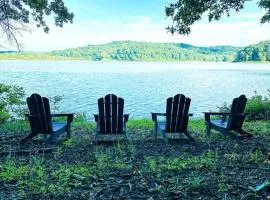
[0, 117, 270, 200]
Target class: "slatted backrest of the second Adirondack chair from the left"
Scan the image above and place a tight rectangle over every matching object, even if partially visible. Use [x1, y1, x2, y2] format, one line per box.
[98, 94, 124, 134]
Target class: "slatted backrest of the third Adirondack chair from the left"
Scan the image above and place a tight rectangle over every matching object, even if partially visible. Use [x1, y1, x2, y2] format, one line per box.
[165, 94, 191, 133]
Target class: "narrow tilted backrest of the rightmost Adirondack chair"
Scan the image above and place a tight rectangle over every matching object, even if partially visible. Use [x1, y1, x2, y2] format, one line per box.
[227, 95, 247, 130]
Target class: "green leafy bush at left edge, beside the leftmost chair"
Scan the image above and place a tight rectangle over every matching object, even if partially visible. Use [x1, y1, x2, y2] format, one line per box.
[0, 83, 25, 124]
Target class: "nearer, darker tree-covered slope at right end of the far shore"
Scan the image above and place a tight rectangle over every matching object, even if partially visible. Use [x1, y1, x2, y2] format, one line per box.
[235, 40, 270, 62]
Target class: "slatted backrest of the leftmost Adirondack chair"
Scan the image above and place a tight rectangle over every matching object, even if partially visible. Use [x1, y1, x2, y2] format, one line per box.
[27, 94, 52, 134]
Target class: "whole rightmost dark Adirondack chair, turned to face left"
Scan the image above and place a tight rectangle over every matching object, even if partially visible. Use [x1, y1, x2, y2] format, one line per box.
[204, 95, 252, 139]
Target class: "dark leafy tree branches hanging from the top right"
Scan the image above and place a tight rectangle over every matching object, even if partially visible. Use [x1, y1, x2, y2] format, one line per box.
[165, 0, 270, 35]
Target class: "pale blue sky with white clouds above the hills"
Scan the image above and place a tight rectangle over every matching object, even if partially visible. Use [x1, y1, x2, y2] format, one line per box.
[0, 0, 270, 51]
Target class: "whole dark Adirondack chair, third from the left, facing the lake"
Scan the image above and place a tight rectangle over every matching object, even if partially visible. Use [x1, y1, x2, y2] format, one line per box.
[151, 94, 194, 143]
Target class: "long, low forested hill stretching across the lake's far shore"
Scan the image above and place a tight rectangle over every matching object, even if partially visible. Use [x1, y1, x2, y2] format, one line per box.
[0, 41, 241, 61]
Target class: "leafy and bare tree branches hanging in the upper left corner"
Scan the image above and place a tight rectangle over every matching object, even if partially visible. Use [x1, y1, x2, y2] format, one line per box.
[0, 0, 74, 49]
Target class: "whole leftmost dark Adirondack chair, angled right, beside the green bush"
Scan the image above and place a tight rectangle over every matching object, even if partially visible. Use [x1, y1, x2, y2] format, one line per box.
[21, 94, 73, 143]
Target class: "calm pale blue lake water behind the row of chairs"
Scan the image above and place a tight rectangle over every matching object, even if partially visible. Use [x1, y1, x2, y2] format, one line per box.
[0, 61, 270, 118]
